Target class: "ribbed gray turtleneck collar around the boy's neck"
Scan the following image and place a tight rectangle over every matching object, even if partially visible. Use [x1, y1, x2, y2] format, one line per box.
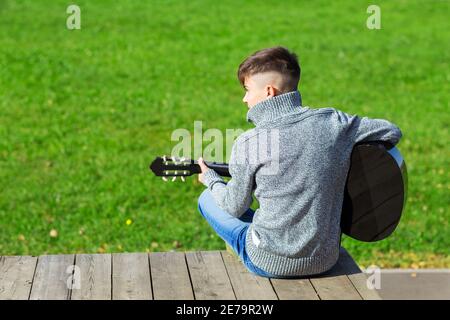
[247, 90, 302, 126]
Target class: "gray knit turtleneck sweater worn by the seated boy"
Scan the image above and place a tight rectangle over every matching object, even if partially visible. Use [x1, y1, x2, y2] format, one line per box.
[204, 91, 402, 276]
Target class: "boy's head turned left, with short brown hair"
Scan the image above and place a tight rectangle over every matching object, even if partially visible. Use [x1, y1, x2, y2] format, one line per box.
[238, 47, 300, 108]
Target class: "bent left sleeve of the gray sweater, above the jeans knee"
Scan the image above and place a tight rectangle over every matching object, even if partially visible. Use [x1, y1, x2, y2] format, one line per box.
[203, 139, 255, 218]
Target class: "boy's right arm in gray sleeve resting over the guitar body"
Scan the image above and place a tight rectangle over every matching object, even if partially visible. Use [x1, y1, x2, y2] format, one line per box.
[336, 110, 402, 146]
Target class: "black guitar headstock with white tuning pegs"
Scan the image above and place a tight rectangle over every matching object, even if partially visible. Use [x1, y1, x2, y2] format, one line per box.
[150, 156, 199, 182]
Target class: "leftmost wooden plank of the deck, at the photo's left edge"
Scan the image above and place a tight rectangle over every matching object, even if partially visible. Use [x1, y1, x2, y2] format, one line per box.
[0, 256, 37, 300]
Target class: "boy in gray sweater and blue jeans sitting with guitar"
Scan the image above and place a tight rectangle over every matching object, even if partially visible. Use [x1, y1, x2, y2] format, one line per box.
[198, 47, 402, 278]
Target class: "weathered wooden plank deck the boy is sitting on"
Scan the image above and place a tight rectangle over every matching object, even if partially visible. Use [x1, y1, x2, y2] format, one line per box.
[0, 249, 379, 300]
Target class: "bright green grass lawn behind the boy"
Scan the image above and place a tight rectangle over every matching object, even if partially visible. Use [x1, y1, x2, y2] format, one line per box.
[0, 0, 450, 267]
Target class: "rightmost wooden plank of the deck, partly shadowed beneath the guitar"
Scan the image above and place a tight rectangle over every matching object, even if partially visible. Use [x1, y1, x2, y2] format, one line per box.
[338, 248, 381, 300]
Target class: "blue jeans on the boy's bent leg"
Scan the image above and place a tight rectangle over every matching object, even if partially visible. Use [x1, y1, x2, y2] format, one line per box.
[198, 189, 276, 278]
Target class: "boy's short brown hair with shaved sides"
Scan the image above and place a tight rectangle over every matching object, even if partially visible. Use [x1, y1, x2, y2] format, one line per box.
[237, 46, 301, 93]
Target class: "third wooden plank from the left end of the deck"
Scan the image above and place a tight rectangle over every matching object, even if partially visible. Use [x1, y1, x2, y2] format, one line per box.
[71, 254, 111, 300]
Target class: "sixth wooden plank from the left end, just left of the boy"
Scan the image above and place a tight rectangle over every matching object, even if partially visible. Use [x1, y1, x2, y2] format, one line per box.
[186, 251, 236, 300]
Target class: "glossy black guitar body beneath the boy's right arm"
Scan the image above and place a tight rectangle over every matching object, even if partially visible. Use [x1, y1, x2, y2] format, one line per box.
[341, 143, 408, 242]
